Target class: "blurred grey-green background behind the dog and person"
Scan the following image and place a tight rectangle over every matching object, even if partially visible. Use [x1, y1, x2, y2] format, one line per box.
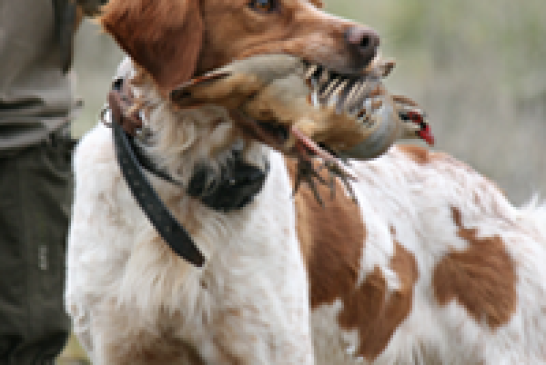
[74, 0, 546, 204]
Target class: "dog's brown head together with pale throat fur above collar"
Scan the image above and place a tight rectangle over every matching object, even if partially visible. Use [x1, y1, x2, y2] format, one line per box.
[99, 0, 379, 191]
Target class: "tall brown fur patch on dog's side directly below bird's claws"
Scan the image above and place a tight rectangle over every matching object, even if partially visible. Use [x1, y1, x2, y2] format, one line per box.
[286, 159, 366, 308]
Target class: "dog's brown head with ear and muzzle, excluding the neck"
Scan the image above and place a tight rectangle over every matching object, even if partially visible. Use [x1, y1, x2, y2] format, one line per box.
[100, 0, 379, 93]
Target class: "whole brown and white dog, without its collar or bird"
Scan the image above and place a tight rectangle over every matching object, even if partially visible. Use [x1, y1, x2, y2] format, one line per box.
[66, 0, 546, 365]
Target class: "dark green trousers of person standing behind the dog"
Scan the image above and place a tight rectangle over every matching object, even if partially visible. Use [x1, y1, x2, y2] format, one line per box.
[0, 136, 72, 365]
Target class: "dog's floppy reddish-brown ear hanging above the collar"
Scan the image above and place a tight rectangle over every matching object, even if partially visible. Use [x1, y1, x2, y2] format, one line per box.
[100, 0, 203, 93]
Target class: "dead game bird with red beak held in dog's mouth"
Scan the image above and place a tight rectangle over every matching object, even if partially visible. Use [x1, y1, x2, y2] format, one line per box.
[170, 54, 434, 202]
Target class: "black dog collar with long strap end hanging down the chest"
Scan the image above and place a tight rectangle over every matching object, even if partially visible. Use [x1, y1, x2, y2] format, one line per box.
[108, 79, 269, 267]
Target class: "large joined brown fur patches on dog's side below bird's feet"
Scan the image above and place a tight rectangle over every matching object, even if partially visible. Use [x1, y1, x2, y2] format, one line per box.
[287, 160, 418, 360]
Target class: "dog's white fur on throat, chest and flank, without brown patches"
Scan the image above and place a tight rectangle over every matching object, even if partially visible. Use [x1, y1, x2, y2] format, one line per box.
[66, 61, 546, 365]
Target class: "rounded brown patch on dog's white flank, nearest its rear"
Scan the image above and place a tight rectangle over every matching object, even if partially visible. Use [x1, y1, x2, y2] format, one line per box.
[432, 207, 517, 329]
